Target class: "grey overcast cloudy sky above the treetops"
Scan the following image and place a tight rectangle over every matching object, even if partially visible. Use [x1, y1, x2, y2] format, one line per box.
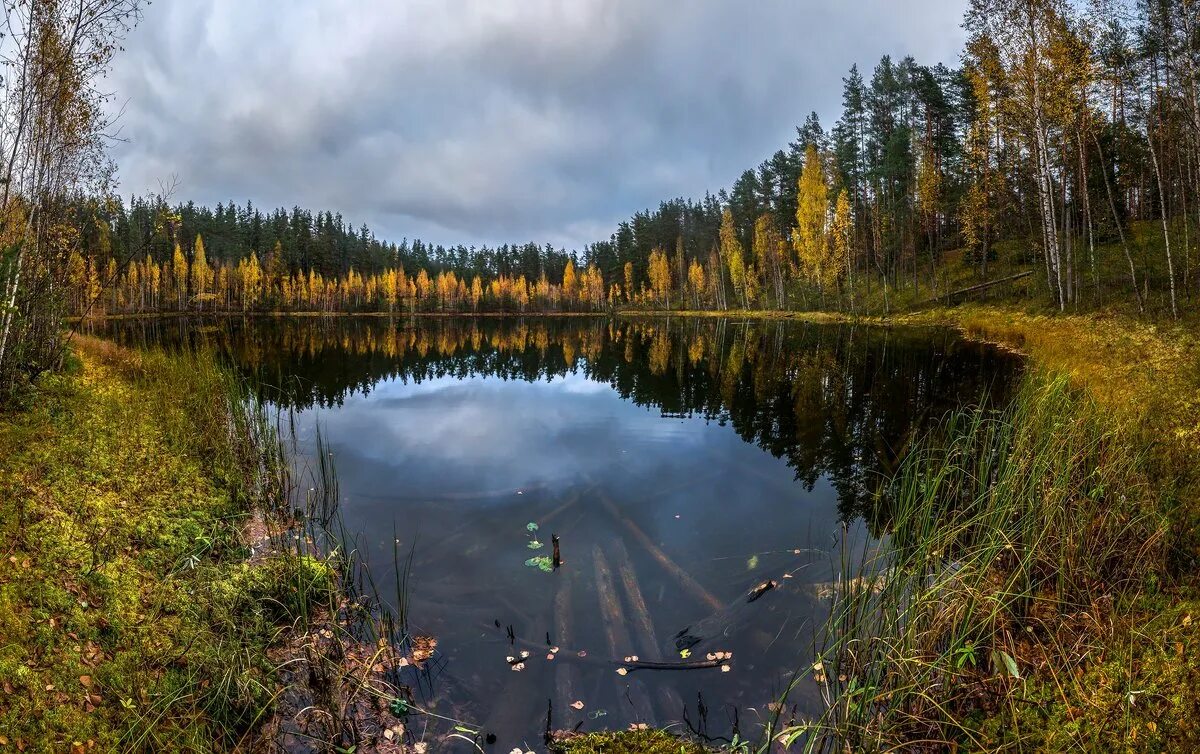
[108, 0, 966, 247]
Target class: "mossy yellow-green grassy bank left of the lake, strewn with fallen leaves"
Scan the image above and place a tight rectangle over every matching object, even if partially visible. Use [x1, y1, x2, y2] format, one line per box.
[0, 339, 330, 752]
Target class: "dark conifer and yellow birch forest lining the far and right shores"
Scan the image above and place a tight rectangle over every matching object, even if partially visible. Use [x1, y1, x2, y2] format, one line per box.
[51, 0, 1200, 317]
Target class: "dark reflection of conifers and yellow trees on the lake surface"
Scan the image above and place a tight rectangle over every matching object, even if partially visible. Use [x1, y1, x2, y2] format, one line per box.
[96, 318, 1019, 515]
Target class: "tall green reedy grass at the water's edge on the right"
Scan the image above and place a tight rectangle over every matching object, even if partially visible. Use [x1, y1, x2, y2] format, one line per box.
[768, 373, 1166, 750]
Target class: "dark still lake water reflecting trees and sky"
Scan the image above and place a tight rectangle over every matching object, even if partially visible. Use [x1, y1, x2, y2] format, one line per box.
[91, 318, 1020, 752]
